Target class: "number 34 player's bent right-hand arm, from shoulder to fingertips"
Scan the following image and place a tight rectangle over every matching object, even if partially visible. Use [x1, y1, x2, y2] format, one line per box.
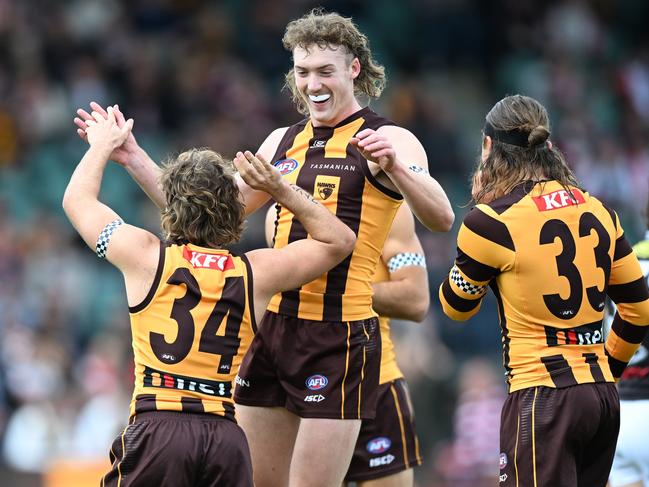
[234, 152, 356, 309]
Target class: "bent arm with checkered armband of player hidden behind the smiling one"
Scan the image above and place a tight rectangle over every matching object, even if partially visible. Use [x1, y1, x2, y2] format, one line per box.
[372, 204, 430, 321]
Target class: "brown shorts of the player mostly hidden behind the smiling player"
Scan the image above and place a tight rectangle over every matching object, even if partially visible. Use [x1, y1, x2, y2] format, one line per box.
[345, 379, 421, 482]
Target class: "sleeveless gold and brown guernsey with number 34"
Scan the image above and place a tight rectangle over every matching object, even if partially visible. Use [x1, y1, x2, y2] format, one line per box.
[129, 244, 256, 420]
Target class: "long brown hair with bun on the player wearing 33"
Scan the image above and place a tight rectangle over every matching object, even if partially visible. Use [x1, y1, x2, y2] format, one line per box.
[472, 95, 578, 203]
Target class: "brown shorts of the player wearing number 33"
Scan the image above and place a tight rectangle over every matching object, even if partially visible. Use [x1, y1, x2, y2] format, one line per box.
[499, 383, 620, 487]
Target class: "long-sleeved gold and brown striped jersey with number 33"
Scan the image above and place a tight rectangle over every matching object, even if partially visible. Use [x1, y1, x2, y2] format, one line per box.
[439, 181, 649, 392]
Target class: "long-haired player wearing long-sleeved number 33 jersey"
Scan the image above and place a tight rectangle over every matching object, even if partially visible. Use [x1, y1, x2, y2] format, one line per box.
[439, 95, 649, 487]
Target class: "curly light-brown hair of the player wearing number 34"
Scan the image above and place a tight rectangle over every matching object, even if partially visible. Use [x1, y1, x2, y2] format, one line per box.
[160, 149, 245, 248]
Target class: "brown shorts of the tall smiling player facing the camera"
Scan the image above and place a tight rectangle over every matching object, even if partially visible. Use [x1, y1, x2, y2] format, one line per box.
[234, 312, 381, 419]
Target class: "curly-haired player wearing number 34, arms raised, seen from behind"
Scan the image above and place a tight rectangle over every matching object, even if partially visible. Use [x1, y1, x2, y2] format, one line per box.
[63, 107, 355, 487]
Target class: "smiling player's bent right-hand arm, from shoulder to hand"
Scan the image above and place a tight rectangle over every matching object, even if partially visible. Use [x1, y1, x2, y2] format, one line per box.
[351, 125, 455, 232]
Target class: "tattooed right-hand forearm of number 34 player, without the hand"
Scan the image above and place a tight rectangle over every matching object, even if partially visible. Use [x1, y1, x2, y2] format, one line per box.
[271, 183, 356, 251]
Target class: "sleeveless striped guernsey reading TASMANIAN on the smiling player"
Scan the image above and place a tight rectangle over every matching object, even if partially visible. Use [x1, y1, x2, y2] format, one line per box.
[268, 108, 402, 321]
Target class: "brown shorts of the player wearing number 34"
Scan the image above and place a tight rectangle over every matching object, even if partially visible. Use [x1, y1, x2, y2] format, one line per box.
[101, 411, 253, 487]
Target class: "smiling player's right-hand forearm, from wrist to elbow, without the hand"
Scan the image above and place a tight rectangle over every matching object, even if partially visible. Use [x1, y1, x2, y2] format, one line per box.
[388, 161, 455, 232]
